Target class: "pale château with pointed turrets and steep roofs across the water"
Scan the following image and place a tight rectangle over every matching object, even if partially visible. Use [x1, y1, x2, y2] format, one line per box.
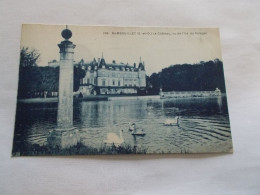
[48, 54, 146, 96]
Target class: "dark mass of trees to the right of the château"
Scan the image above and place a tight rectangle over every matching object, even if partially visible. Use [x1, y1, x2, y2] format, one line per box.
[146, 59, 226, 94]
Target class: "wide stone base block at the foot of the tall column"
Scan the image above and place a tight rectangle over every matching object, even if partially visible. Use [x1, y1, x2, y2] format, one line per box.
[47, 127, 80, 149]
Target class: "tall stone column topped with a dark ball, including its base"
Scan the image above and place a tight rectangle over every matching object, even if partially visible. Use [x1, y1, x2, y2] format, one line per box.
[47, 28, 80, 149]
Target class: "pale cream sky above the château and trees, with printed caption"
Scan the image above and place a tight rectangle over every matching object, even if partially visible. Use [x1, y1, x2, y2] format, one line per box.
[21, 24, 222, 75]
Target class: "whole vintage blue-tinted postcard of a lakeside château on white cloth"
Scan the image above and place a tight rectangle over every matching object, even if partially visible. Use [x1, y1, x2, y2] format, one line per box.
[12, 24, 233, 156]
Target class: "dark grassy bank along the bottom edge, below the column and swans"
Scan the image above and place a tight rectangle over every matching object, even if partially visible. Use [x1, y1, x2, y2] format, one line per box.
[12, 143, 147, 156]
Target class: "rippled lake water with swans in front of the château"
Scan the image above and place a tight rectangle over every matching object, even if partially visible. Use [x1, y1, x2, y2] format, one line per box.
[14, 96, 232, 153]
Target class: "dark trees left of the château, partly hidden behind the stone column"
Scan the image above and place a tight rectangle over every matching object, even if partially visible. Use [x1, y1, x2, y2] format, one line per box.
[18, 47, 86, 98]
